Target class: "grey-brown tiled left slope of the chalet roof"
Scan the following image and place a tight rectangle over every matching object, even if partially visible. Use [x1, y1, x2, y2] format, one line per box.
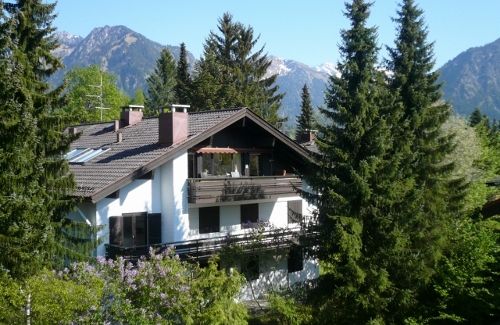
[70, 109, 242, 197]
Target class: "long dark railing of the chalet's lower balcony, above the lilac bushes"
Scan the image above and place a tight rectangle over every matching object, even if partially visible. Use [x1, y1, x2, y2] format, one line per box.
[105, 226, 314, 260]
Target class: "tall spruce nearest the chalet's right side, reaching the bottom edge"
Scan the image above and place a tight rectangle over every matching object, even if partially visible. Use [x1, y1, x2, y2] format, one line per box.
[306, 0, 399, 324]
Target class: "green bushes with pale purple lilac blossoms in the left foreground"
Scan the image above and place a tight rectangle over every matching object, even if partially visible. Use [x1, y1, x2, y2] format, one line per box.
[0, 252, 247, 324]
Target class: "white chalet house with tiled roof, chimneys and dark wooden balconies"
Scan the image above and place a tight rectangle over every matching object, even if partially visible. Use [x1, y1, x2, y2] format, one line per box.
[66, 105, 318, 299]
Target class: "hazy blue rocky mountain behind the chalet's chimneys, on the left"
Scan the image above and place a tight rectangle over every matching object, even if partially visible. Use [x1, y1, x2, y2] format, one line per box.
[50, 26, 194, 96]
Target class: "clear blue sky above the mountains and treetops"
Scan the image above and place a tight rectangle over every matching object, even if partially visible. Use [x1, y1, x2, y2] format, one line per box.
[54, 0, 500, 67]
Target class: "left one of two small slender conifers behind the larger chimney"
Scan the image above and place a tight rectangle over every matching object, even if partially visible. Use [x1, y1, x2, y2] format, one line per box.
[145, 48, 177, 114]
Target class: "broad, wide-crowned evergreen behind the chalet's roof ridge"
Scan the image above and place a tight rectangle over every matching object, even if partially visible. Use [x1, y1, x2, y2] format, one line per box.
[193, 13, 283, 126]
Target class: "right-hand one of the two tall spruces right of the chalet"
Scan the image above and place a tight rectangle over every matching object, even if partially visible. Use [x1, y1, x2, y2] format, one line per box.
[389, 0, 465, 272]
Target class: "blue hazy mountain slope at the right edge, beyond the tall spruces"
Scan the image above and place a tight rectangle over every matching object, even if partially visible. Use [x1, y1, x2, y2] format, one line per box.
[440, 38, 500, 120]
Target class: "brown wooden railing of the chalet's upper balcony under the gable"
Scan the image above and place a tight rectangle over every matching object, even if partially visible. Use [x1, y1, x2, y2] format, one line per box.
[188, 175, 302, 204]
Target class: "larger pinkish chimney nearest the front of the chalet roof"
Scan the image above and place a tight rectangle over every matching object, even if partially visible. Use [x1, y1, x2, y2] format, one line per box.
[158, 104, 190, 146]
